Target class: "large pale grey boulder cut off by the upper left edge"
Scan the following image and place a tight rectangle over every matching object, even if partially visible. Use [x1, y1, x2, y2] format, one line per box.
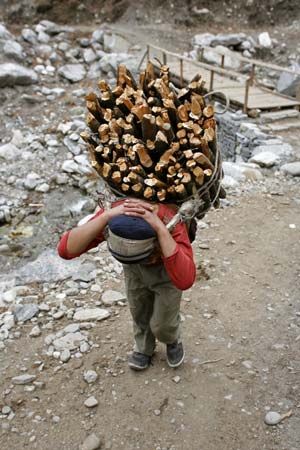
[0, 63, 38, 88]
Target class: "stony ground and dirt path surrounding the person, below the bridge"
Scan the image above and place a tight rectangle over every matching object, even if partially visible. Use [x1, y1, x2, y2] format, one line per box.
[0, 7, 300, 450]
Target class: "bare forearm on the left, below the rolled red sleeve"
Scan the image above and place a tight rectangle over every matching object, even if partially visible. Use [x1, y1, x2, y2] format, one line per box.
[67, 211, 109, 254]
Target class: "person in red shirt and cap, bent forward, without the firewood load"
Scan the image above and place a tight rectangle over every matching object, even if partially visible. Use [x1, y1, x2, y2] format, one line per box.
[58, 198, 196, 370]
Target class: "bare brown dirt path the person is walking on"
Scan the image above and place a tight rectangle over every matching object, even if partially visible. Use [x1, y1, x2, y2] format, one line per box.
[0, 181, 300, 450]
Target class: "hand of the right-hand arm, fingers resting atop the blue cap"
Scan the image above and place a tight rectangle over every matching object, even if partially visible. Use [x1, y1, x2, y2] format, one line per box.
[124, 199, 165, 233]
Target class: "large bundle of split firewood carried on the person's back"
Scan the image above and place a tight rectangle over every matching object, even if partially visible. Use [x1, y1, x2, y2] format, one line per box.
[81, 62, 221, 206]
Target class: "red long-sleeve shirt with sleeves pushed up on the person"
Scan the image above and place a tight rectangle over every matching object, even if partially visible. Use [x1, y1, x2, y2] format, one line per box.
[57, 202, 196, 291]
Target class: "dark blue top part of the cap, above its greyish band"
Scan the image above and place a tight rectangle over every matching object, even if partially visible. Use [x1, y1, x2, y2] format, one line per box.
[108, 214, 156, 240]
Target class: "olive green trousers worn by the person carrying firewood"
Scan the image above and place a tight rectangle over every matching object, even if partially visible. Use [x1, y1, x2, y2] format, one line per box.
[123, 264, 182, 356]
